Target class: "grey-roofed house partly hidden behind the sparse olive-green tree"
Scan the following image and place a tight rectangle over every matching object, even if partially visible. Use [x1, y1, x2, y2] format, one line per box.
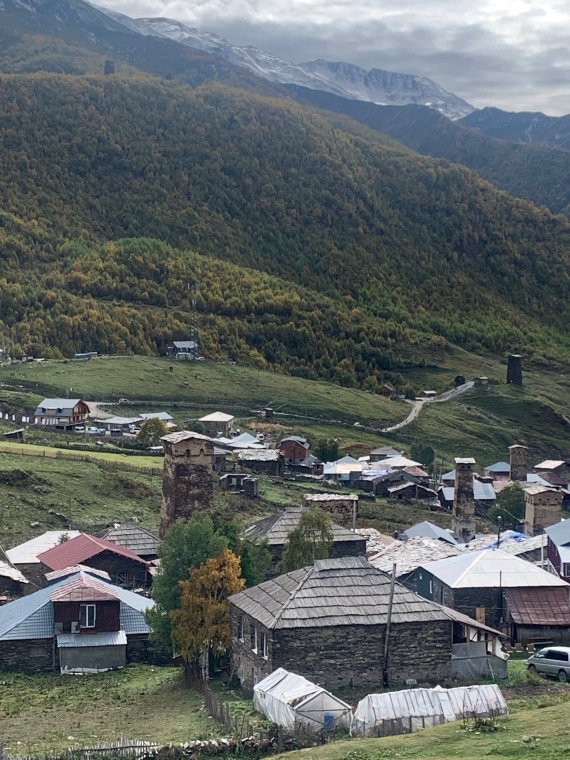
[244, 507, 366, 578]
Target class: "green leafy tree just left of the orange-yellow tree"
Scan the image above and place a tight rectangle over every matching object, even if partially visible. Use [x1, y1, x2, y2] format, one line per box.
[146, 515, 228, 652]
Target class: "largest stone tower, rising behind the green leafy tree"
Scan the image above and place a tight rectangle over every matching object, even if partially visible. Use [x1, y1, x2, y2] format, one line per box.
[159, 430, 214, 538]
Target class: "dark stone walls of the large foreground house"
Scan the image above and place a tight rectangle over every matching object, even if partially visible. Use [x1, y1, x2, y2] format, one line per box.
[232, 608, 452, 690]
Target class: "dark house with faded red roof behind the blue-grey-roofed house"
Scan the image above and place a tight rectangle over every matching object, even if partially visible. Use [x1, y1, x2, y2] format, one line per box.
[38, 533, 150, 588]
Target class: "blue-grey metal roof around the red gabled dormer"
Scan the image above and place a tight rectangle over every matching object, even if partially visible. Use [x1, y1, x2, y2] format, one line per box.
[0, 573, 154, 641]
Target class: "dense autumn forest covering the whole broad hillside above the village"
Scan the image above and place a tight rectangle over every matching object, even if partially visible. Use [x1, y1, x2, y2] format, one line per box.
[0, 72, 570, 388]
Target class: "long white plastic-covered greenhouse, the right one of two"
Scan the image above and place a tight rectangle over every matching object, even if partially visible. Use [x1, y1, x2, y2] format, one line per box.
[352, 684, 508, 736]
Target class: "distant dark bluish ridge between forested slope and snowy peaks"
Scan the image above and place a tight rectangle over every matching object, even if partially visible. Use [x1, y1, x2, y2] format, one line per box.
[289, 87, 570, 216]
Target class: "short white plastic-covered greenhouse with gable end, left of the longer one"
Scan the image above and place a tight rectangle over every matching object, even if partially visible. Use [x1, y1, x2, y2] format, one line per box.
[253, 668, 352, 731]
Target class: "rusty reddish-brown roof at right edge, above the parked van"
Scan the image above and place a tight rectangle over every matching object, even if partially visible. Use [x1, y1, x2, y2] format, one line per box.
[505, 588, 570, 626]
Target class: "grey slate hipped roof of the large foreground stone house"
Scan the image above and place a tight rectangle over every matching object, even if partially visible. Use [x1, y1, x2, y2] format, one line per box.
[230, 557, 449, 629]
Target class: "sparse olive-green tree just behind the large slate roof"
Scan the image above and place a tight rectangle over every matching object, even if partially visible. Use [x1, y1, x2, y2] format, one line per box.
[279, 507, 334, 573]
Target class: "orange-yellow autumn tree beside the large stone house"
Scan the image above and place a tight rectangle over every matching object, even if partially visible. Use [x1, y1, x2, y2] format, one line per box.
[170, 549, 245, 681]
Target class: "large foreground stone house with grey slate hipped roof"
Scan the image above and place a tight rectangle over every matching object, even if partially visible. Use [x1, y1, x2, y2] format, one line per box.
[229, 557, 500, 690]
